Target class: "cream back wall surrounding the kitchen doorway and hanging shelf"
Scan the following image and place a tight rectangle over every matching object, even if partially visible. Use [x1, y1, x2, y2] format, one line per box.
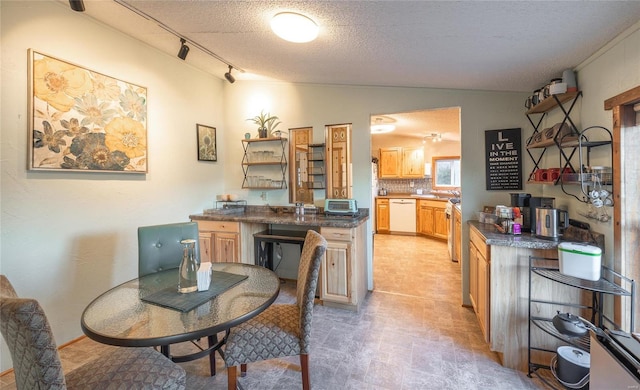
[225, 81, 529, 310]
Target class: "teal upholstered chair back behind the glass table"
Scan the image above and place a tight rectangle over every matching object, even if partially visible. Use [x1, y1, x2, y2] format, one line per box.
[138, 222, 200, 276]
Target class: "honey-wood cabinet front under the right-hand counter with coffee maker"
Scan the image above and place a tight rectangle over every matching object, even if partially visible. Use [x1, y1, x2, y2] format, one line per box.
[469, 226, 491, 343]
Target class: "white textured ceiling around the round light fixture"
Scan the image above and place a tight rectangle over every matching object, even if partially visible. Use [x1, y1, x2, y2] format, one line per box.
[77, 0, 640, 91]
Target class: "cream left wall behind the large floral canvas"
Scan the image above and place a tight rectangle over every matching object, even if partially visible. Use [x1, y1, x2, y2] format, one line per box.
[0, 0, 226, 371]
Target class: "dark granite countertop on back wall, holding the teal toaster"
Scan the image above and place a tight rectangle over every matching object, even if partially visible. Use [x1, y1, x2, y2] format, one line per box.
[189, 206, 369, 228]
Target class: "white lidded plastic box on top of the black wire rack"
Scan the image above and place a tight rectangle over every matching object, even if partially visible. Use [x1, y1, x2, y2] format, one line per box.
[558, 242, 602, 280]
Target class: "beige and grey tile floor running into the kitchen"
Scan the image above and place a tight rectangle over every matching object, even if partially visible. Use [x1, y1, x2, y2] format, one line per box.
[0, 235, 543, 390]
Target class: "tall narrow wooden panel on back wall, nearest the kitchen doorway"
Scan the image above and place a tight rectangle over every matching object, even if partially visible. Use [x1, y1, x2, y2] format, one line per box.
[325, 123, 353, 199]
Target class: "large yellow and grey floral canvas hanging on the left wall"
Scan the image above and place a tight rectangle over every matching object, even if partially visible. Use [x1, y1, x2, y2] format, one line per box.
[28, 49, 147, 173]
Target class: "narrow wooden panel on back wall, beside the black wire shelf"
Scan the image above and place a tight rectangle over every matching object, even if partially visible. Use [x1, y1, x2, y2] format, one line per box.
[289, 127, 313, 203]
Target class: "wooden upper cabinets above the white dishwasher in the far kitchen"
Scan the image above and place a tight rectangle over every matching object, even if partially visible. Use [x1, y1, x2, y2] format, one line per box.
[378, 147, 424, 179]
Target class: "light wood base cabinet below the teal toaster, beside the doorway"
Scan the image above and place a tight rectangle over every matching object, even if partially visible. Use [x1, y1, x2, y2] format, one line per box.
[319, 224, 367, 310]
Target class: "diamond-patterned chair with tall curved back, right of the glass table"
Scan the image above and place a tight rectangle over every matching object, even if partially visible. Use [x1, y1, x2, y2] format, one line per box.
[224, 230, 327, 390]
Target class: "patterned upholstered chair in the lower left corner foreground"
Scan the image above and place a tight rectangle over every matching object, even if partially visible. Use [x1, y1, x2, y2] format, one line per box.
[0, 275, 186, 390]
